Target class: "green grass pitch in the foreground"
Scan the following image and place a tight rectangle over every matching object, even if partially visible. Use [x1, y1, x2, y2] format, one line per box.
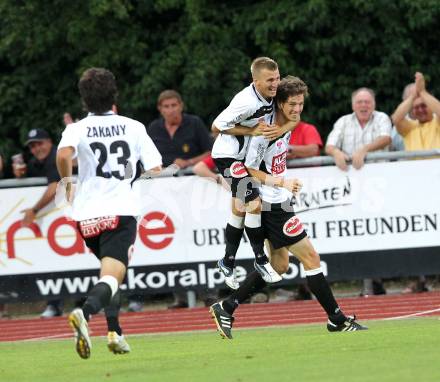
[0, 317, 440, 382]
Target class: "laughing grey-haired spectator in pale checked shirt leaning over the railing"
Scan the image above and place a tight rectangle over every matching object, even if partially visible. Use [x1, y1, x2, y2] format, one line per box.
[325, 88, 391, 295]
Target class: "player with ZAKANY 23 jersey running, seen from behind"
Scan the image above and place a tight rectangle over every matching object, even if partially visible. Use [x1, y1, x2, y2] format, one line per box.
[57, 68, 162, 358]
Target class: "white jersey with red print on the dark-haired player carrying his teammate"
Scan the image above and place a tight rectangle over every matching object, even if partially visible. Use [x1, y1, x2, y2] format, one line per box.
[245, 122, 292, 203]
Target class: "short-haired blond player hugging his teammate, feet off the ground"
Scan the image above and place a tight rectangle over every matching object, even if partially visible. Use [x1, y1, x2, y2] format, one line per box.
[212, 57, 295, 289]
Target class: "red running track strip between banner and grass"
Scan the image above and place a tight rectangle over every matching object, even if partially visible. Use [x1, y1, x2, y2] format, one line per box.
[0, 292, 440, 342]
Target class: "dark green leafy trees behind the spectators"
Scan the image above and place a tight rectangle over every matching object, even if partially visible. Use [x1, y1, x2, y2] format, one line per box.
[0, 0, 440, 158]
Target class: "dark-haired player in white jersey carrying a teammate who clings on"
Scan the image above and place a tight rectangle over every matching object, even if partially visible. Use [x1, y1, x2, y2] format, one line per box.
[210, 76, 366, 339]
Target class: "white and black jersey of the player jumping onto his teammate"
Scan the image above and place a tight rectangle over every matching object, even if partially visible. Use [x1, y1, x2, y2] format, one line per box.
[211, 84, 274, 160]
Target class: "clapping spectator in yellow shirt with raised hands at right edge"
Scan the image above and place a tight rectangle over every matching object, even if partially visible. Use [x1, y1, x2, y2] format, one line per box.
[392, 72, 440, 151]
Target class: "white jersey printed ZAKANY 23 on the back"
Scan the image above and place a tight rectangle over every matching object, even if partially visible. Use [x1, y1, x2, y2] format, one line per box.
[58, 111, 162, 221]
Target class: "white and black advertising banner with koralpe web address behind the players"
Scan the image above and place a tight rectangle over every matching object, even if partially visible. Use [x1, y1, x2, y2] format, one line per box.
[0, 159, 440, 299]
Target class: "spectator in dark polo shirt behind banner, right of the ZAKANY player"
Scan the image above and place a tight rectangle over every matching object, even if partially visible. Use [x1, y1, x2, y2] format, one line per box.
[147, 90, 212, 168]
